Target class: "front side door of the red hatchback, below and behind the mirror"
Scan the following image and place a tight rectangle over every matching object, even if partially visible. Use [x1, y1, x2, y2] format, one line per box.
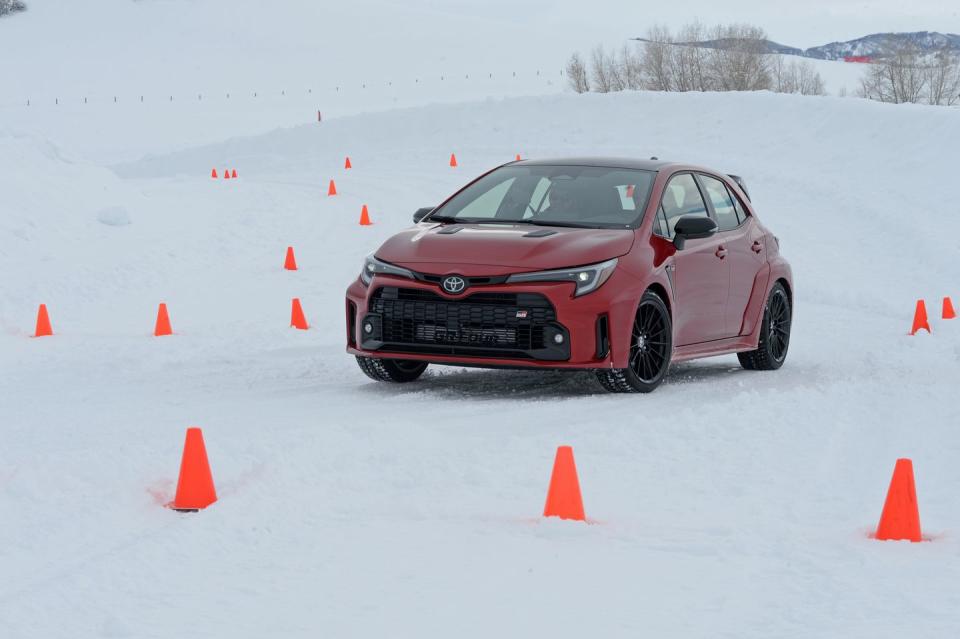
[658, 173, 730, 346]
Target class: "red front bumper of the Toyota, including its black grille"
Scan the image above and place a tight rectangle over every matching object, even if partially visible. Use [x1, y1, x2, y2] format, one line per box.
[346, 269, 642, 369]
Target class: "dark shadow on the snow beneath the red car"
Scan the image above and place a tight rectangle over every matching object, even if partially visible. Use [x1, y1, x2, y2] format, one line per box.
[352, 361, 747, 399]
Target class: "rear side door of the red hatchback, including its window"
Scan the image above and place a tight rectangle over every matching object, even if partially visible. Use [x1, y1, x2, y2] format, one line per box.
[697, 173, 766, 337]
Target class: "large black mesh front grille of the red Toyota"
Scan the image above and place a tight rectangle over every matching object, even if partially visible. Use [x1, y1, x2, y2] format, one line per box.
[369, 287, 567, 359]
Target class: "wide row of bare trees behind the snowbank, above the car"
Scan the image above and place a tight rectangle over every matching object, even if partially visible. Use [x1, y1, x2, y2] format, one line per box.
[566, 23, 825, 95]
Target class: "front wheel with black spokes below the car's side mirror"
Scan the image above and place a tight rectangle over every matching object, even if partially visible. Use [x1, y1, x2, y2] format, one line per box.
[596, 291, 673, 393]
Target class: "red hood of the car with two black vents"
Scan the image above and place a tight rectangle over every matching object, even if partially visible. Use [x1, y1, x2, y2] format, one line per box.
[376, 223, 634, 275]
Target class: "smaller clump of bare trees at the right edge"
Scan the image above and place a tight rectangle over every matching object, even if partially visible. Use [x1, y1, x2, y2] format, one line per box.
[860, 44, 960, 106]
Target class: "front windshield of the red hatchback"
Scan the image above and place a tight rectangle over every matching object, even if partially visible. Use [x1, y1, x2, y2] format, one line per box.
[427, 165, 656, 228]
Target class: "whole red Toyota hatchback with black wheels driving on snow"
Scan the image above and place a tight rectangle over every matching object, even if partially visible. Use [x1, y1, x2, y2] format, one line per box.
[346, 158, 793, 392]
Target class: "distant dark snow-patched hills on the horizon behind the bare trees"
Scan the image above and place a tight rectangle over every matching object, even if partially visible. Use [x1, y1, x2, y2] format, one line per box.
[635, 31, 960, 60]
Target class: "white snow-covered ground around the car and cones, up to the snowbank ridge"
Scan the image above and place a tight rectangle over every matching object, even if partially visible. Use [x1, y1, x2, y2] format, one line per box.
[0, 2, 960, 639]
